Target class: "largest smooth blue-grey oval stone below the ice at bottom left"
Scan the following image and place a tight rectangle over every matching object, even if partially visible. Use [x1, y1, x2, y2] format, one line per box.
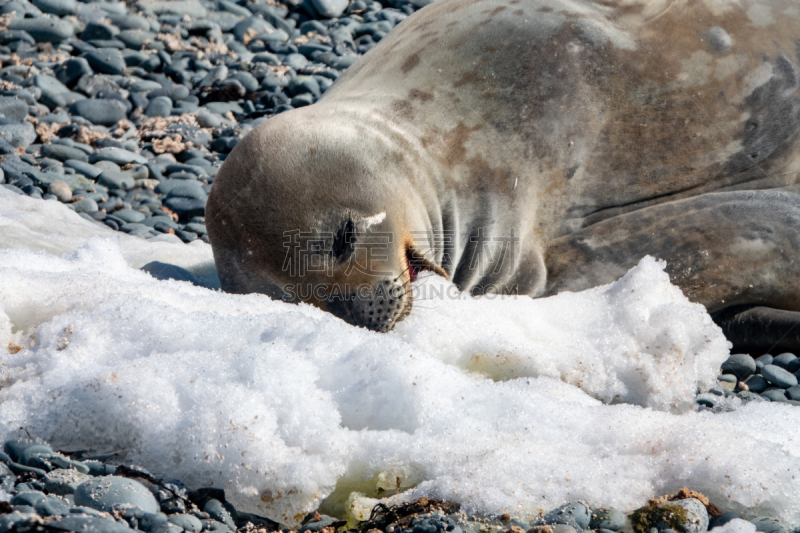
[75, 476, 159, 513]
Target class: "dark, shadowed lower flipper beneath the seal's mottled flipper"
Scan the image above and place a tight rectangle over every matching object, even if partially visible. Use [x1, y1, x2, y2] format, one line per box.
[714, 306, 800, 357]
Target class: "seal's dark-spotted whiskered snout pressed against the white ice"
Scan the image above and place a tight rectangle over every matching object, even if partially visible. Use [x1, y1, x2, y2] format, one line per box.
[326, 279, 412, 333]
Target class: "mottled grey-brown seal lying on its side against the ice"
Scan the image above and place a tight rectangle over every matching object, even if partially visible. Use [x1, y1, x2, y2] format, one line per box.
[206, 0, 800, 341]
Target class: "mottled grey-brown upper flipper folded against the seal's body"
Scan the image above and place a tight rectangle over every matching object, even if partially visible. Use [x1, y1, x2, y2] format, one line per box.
[545, 188, 800, 313]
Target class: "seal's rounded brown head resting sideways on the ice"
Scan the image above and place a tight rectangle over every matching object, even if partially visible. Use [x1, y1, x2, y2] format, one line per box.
[206, 106, 446, 331]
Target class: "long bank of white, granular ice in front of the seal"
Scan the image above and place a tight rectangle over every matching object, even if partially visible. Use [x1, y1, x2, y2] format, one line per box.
[0, 188, 800, 533]
